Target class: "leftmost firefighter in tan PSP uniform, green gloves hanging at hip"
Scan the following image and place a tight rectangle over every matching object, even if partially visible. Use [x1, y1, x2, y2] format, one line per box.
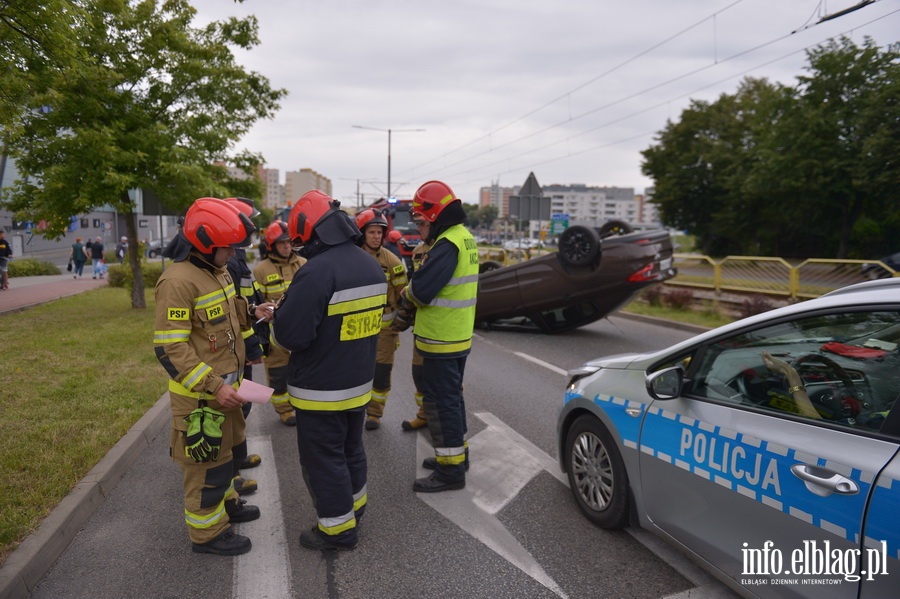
[153, 198, 273, 555]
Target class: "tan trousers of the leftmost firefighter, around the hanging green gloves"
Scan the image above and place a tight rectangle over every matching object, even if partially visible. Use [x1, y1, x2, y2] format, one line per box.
[169, 393, 246, 543]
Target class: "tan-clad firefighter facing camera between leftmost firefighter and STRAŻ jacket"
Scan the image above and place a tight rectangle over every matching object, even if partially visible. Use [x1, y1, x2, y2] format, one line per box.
[253, 221, 306, 426]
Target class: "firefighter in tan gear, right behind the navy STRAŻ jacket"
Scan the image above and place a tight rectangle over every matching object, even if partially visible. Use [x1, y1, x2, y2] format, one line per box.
[356, 208, 407, 431]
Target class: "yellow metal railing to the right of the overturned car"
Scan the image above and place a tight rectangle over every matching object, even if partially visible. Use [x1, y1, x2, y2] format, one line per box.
[666, 254, 900, 300]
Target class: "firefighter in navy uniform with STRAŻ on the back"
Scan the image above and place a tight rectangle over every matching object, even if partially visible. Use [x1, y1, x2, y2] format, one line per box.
[272, 190, 387, 550]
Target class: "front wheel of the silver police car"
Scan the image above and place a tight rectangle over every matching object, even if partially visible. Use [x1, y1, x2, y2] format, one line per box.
[565, 415, 631, 529]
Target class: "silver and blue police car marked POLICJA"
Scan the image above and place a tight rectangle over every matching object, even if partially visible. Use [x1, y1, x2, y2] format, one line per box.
[557, 278, 900, 599]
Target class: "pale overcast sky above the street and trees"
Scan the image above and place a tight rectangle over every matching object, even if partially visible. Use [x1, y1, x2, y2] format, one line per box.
[186, 0, 900, 204]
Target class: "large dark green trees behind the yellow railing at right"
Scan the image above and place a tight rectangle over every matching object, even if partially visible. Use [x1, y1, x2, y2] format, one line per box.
[642, 38, 900, 258]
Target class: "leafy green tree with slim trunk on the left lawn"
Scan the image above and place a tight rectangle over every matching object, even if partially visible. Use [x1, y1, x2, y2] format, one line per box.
[0, 0, 286, 308]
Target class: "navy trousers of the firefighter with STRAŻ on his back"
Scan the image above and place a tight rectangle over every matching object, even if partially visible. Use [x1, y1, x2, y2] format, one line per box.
[297, 408, 367, 545]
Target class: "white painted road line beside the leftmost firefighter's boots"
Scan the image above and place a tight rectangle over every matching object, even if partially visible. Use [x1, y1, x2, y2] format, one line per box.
[232, 435, 292, 597]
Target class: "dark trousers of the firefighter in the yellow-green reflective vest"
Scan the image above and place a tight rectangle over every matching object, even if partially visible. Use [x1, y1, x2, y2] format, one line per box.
[422, 356, 468, 482]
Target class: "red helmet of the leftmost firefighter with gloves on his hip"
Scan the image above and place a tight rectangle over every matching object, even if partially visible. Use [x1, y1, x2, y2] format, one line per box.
[181, 198, 256, 254]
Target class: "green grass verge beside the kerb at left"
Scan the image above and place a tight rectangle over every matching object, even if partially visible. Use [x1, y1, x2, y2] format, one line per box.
[0, 287, 166, 563]
